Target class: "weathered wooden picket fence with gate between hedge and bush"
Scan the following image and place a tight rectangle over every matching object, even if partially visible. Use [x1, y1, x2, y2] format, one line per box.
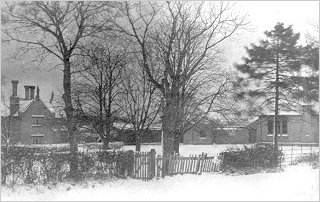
[132, 149, 222, 181]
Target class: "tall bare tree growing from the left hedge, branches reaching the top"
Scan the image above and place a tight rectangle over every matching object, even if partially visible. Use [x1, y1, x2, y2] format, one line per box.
[2, 1, 116, 178]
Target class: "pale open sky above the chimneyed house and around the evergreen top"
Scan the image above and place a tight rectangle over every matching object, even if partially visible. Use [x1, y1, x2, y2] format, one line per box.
[1, 1, 319, 103]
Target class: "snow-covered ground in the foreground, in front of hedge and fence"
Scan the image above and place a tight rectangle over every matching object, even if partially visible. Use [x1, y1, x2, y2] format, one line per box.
[1, 165, 319, 201]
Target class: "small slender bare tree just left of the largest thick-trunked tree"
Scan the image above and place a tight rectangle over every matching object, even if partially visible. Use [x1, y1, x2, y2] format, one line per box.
[120, 63, 160, 151]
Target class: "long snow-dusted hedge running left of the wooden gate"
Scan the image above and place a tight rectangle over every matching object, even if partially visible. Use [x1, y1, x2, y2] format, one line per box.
[1, 147, 134, 184]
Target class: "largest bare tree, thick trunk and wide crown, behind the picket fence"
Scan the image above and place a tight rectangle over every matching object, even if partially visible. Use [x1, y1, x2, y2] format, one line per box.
[114, 2, 245, 155]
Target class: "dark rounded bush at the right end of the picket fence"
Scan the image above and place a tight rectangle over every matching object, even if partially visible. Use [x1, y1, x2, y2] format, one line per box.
[222, 145, 283, 170]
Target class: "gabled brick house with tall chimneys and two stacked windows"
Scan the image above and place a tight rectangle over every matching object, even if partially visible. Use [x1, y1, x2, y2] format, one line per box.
[1, 81, 68, 145]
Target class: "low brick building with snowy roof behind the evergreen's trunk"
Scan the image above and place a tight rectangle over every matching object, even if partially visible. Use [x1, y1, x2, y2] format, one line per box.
[247, 105, 319, 143]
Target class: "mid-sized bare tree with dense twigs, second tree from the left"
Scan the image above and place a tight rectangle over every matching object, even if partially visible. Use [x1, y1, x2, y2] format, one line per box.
[74, 36, 128, 148]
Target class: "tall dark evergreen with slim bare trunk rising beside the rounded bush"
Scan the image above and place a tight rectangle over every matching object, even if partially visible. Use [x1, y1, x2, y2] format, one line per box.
[235, 23, 302, 152]
